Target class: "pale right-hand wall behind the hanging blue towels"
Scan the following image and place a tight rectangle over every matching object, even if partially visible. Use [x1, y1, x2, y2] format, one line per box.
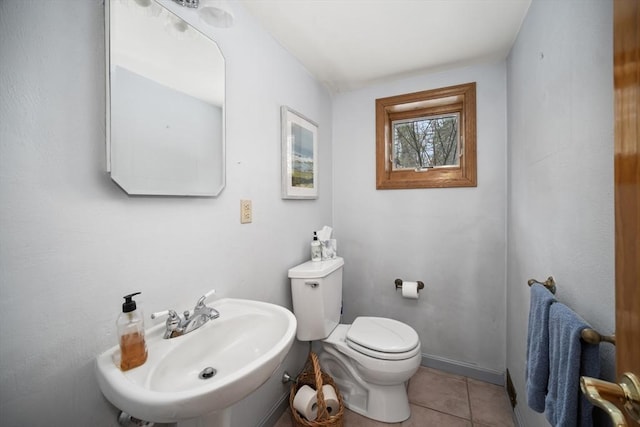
[507, 0, 615, 426]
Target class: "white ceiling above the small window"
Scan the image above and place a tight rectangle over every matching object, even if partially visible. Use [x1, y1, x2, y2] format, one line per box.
[238, 0, 531, 92]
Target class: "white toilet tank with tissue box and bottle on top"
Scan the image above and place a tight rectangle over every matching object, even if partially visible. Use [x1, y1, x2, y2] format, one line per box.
[289, 257, 344, 341]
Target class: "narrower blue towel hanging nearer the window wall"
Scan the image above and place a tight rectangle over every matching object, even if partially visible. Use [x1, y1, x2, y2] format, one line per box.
[526, 283, 556, 412]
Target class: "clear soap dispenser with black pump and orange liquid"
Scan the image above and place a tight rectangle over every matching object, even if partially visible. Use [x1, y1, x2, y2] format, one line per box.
[116, 292, 147, 371]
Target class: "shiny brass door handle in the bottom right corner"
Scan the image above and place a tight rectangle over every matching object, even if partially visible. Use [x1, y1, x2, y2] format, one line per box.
[580, 372, 640, 427]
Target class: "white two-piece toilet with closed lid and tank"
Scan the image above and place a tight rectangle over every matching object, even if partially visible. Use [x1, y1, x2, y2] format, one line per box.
[289, 257, 422, 423]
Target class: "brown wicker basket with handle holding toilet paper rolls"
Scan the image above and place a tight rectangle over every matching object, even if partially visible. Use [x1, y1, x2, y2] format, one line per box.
[289, 351, 344, 427]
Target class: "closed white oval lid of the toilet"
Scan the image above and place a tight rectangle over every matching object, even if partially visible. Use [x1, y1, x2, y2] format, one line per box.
[347, 317, 419, 353]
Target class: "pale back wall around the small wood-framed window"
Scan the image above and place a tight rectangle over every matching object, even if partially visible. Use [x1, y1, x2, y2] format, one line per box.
[333, 61, 506, 374]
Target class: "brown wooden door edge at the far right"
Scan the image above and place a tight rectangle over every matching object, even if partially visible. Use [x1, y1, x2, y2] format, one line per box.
[613, 0, 640, 376]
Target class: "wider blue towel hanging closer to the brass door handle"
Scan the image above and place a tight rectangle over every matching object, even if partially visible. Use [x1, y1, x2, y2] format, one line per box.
[545, 303, 600, 427]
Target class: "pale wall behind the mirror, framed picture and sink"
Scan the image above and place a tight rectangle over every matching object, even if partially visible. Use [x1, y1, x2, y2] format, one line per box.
[0, 0, 332, 427]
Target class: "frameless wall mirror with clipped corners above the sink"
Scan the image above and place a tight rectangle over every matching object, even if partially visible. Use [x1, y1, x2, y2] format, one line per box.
[105, 0, 225, 196]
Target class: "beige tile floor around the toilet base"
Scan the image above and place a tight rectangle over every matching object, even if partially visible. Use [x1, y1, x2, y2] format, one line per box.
[274, 367, 515, 427]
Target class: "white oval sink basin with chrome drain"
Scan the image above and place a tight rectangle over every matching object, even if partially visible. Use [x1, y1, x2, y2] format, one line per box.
[96, 298, 296, 423]
